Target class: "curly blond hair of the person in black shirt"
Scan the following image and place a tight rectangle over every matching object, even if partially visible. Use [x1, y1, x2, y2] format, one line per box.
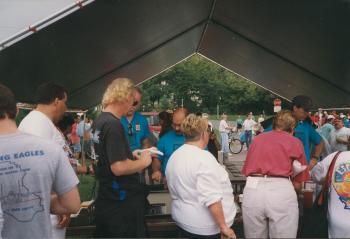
[102, 78, 135, 108]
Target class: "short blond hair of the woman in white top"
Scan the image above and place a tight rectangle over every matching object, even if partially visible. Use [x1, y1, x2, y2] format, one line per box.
[181, 114, 208, 141]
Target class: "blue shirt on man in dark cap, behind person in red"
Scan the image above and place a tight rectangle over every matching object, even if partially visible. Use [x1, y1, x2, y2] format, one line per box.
[264, 121, 322, 163]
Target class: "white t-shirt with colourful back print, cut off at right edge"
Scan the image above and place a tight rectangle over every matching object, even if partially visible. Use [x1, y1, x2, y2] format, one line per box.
[311, 151, 350, 238]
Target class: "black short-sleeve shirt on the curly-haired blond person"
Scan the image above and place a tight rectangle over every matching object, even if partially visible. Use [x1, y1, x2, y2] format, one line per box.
[92, 112, 144, 201]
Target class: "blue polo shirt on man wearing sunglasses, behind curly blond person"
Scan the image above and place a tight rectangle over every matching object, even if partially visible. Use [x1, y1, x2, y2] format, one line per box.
[120, 112, 151, 151]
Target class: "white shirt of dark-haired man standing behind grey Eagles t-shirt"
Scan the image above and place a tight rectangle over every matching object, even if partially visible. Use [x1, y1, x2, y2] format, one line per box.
[18, 110, 65, 148]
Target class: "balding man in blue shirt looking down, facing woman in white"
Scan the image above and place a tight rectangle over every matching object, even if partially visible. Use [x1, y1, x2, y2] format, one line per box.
[152, 108, 188, 181]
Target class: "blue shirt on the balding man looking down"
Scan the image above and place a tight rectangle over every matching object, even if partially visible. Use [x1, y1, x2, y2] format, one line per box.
[157, 130, 185, 175]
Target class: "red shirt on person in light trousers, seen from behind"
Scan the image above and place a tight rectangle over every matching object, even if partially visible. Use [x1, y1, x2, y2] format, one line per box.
[242, 130, 310, 182]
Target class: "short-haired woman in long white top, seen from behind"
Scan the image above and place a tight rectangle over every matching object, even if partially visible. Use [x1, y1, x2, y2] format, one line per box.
[165, 114, 236, 238]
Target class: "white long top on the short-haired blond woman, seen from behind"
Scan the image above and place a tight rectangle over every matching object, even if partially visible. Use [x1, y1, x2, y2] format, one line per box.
[165, 144, 236, 235]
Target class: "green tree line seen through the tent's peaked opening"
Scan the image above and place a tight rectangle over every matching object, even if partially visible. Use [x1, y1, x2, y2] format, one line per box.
[140, 55, 288, 114]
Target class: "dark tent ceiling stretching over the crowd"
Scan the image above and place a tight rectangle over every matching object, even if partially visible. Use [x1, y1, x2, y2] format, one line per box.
[0, 0, 350, 108]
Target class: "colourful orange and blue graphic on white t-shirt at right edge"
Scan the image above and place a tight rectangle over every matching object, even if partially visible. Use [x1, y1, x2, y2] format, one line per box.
[333, 163, 350, 210]
